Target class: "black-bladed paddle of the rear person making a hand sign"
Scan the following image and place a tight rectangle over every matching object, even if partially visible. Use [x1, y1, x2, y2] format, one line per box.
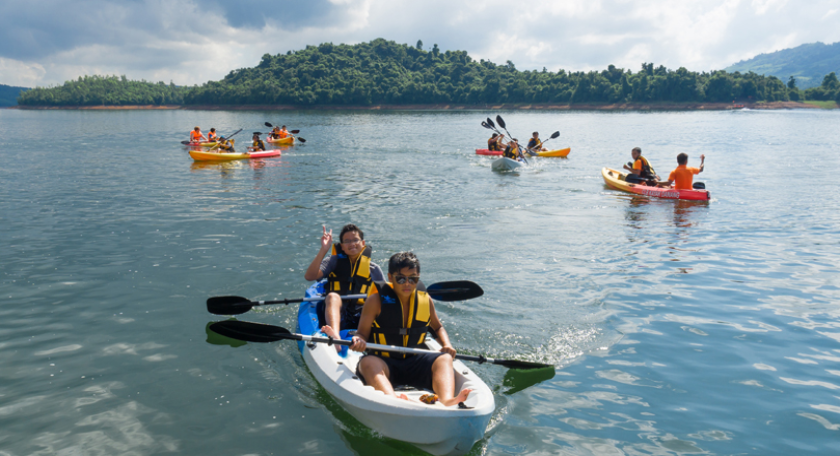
[207, 280, 484, 315]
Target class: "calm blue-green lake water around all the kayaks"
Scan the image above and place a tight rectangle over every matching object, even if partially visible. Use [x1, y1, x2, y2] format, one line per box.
[0, 110, 840, 456]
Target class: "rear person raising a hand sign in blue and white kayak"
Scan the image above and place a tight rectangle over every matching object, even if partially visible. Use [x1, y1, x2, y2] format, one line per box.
[303, 223, 385, 349]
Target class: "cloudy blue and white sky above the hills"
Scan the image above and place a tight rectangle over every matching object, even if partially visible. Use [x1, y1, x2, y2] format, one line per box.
[0, 0, 840, 87]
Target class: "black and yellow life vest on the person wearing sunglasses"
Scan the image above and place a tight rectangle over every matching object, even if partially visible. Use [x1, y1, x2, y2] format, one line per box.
[368, 282, 432, 359]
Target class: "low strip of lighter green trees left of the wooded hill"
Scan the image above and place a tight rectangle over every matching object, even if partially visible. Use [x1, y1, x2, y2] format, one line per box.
[18, 76, 189, 106]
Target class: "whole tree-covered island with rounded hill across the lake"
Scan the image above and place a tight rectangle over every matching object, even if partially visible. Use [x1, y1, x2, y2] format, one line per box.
[13, 39, 840, 107]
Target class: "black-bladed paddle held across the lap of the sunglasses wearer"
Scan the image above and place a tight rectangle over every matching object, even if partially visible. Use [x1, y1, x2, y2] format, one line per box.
[210, 320, 552, 369]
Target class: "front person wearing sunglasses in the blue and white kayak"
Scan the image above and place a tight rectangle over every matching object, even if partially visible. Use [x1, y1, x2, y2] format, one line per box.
[334, 252, 472, 406]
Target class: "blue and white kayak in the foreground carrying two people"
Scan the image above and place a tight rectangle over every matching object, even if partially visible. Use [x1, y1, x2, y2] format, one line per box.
[297, 282, 496, 455]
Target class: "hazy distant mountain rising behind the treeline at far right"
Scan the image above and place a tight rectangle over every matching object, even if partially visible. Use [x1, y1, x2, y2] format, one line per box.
[724, 42, 840, 89]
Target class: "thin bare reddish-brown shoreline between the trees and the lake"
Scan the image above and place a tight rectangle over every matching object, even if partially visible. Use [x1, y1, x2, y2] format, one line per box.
[5, 101, 838, 111]
